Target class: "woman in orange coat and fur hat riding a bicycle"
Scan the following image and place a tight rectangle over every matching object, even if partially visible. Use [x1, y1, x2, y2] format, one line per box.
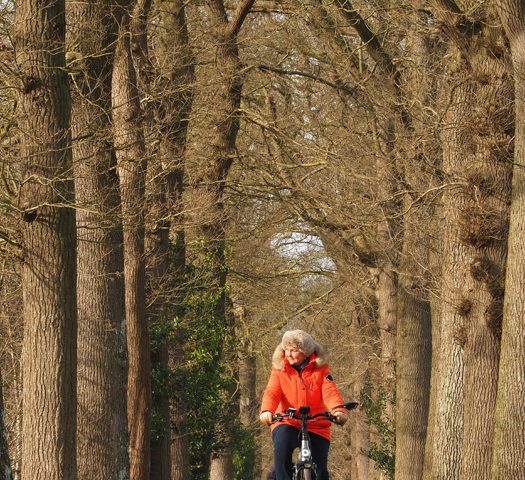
[260, 330, 348, 480]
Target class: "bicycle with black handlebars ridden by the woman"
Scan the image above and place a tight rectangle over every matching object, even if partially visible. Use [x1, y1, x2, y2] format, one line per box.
[272, 402, 359, 480]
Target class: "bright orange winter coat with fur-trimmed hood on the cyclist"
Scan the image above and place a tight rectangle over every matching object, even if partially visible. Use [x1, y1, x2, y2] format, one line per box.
[261, 347, 345, 440]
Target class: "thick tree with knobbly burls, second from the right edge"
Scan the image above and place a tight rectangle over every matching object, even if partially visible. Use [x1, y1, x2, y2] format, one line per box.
[426, 2, 512, 479]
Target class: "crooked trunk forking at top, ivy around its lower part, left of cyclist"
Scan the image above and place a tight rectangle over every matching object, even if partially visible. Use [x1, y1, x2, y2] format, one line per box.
[198, 0, 254, 480]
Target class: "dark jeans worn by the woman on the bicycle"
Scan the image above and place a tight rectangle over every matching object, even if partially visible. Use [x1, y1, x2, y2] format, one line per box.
[272, 425, 330, 480]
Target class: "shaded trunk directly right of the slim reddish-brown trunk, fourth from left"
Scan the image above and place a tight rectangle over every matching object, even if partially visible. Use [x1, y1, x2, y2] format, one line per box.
[141, 0, 195, 480]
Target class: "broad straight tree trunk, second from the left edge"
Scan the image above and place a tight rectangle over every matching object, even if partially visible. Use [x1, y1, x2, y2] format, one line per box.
[68, 0, 129, 480]
